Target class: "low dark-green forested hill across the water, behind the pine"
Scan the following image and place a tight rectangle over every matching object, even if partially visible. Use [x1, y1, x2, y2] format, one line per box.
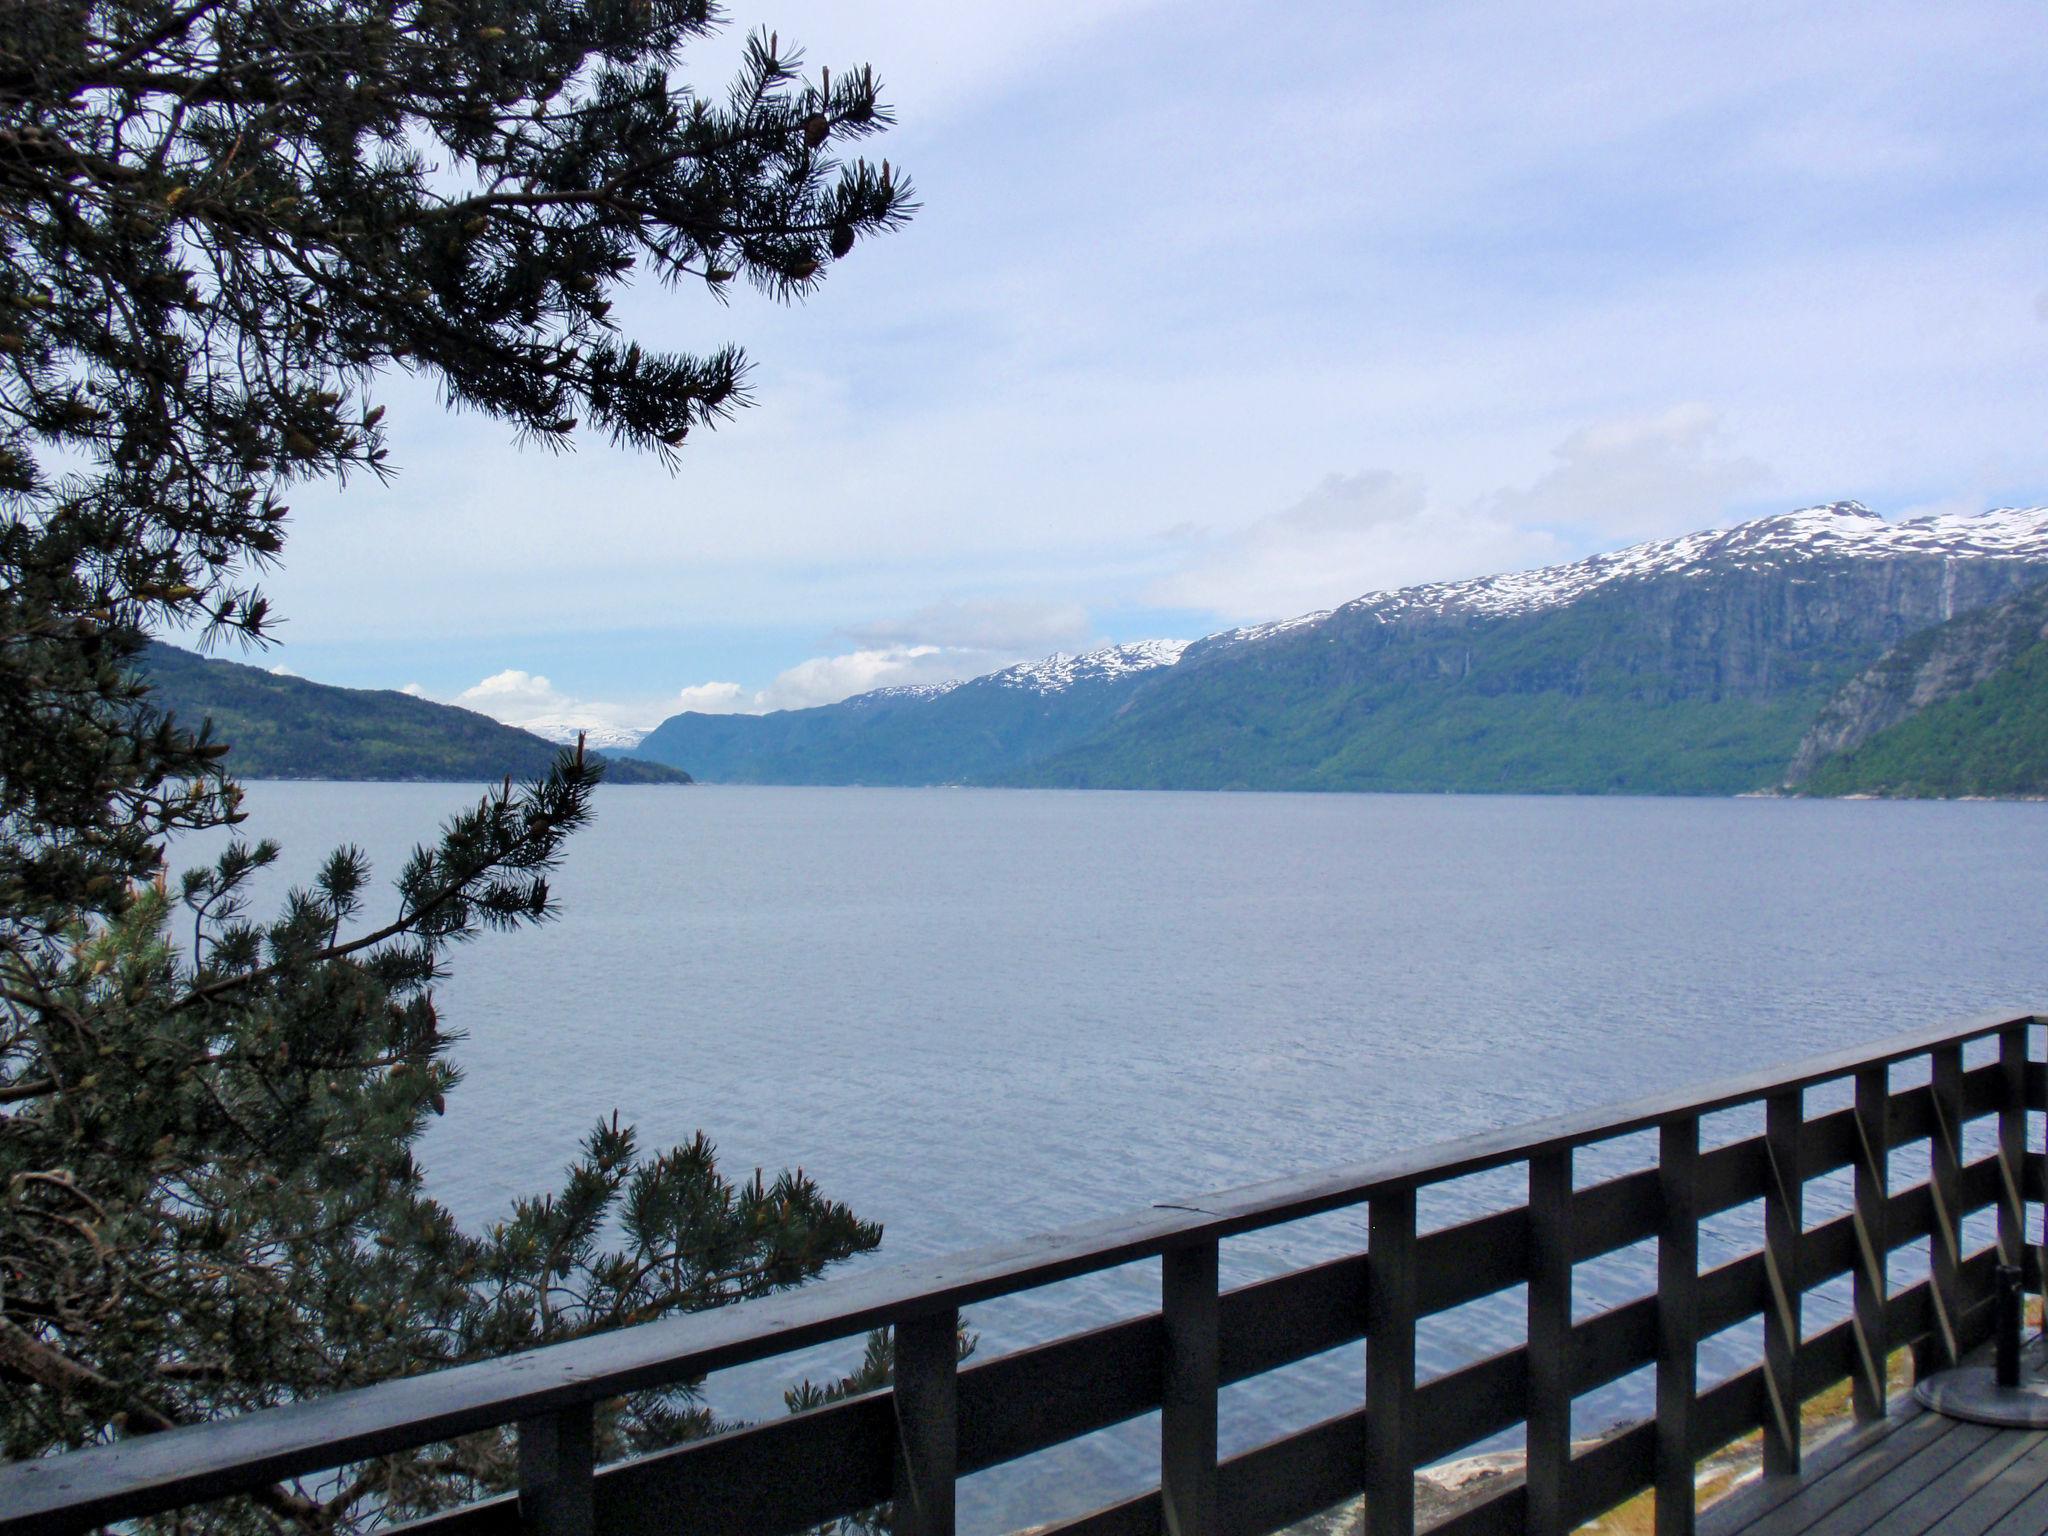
[141, 645, 690, 784]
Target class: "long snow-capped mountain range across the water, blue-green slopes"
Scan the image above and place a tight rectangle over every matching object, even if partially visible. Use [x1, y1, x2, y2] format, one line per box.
[637, 502, 2048, 795]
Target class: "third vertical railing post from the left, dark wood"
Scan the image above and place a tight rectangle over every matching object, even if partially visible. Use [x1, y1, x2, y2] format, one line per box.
[1159, 1239, 1219, 1536]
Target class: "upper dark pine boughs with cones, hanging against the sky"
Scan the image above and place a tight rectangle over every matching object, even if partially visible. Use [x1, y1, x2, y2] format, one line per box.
[0, 0, 907, 922]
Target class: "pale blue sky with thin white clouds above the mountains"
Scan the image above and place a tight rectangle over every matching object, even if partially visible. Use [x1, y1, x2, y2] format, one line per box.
[220, 0, 2048, 741]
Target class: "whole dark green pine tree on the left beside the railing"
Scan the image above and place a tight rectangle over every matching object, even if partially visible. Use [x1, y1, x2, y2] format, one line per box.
[0, 0, 911, 1530]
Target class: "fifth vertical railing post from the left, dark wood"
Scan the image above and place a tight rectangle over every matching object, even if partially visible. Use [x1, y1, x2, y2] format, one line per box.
[1522, 1147, 1573, 1536]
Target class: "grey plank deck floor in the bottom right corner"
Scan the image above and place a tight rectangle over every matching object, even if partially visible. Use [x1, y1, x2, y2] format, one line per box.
[1700, 1399, 2048, 1536]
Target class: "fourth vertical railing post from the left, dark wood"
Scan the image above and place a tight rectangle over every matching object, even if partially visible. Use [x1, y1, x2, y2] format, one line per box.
[1366, 1188, 1415, 1536]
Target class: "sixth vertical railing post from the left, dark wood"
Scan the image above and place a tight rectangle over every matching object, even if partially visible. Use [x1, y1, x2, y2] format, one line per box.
[1657, 1114, 1700, 1536]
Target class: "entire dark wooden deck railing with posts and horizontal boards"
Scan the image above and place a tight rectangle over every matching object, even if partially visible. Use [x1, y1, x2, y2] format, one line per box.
[0, 1014, 2048, 1536]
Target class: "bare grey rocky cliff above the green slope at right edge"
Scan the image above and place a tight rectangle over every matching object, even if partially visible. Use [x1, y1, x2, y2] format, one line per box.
[1786, 586, 2048, 786]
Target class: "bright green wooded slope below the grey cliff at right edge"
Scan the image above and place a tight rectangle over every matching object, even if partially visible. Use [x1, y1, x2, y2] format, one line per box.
[1800, 641, 2048, 797]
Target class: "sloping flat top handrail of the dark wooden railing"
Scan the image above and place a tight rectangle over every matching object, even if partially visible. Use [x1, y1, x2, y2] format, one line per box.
[0, 1012, 2048, 1536]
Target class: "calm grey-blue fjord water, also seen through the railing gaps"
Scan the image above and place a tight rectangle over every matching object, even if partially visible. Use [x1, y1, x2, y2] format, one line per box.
[203, 784, 2048, 1530]
